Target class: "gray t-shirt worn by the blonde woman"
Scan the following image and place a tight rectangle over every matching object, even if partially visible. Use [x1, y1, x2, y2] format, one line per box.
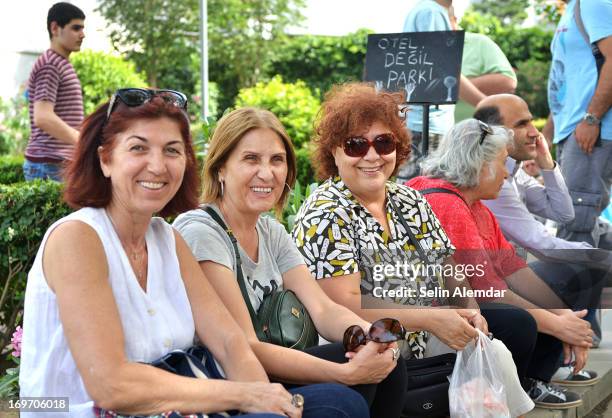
[173, 204, 305, 311]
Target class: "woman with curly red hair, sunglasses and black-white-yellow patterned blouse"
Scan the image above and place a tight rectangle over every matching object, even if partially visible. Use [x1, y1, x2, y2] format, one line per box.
[293, 83, 487, 358]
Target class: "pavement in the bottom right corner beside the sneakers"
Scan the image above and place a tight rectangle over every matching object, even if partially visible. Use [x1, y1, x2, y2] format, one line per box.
[526, 308, 612, 418]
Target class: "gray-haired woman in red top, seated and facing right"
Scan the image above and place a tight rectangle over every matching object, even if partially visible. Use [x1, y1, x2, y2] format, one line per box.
[408, 119, 590, 408]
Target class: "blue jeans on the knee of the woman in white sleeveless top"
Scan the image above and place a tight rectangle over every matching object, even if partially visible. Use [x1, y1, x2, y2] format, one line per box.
[289, 383, 370, 418]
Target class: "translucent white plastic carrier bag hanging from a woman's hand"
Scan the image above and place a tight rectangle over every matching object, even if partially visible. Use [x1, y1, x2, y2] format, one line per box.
[448, 330, 511, 418]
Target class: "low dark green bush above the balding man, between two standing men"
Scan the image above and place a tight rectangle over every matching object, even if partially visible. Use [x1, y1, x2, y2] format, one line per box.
[516, 59, 550, 118]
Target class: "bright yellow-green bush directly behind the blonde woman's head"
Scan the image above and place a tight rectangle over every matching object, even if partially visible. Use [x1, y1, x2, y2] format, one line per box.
[235, 76, 321, 148]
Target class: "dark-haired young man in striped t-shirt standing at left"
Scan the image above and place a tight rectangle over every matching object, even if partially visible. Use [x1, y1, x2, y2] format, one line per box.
[23, 3, 85, 181]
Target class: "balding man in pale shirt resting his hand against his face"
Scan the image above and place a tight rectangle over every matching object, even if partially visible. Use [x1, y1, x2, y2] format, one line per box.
[474, 94, 612, 396]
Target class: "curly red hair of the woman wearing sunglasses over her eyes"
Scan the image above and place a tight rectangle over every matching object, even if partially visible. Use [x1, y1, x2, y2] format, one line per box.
[312, 83, 410, 180]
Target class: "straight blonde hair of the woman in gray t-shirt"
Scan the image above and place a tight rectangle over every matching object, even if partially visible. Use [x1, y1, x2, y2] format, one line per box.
[200, 107, 297, 218]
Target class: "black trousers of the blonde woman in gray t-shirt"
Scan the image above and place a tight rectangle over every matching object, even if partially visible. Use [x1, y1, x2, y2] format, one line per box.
[294, 343, 407, 418]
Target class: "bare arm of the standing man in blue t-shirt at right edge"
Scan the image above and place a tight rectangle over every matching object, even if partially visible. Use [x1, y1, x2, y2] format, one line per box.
[576, 36, 612, 154]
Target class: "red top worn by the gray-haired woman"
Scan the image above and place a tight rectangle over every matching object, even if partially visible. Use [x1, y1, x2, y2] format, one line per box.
[406, 177, 527, 290]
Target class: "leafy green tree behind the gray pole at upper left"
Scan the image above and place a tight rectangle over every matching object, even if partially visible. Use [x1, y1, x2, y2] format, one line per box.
[98, 0, 304, 114]
